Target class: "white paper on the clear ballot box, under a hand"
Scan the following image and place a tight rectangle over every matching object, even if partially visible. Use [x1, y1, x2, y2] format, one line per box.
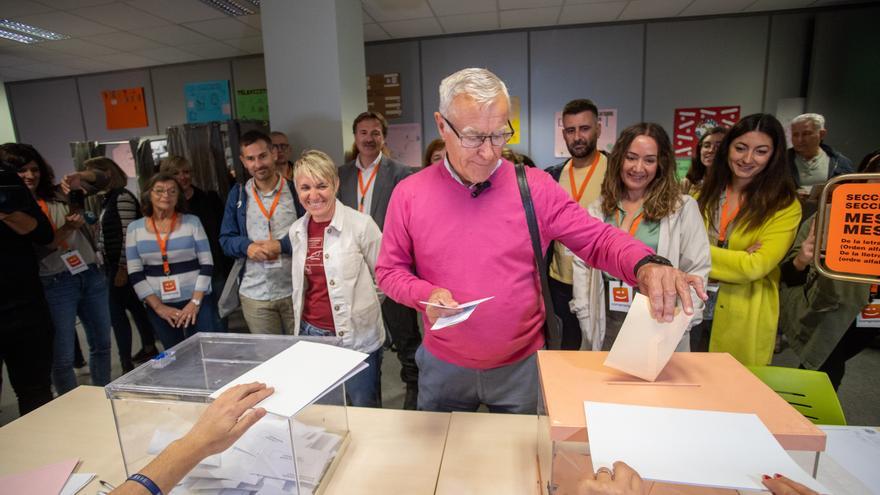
[211, 341, 368, 417]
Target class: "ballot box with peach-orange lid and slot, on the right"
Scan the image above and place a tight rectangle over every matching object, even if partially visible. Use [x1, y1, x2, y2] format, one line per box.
[537, 351, 825, 495]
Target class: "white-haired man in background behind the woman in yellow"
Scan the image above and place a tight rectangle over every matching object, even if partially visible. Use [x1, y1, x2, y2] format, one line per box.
[788, 113, 854, 187]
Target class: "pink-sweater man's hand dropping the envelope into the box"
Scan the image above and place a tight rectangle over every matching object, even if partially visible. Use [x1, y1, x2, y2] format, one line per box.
[636, 263, 709, 322]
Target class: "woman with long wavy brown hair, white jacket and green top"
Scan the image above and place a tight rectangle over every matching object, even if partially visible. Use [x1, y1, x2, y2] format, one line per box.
[570, 123, 711, 351]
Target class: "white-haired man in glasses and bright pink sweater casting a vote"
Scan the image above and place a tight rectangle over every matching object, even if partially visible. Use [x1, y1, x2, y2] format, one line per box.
[376, 69, 705, 414]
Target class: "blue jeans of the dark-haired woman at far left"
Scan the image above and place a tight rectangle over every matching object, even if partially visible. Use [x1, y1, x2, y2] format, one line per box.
[40, 265, 110, 395]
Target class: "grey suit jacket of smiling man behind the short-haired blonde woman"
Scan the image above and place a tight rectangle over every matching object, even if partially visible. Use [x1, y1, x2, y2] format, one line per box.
[337, 154, 415, 229]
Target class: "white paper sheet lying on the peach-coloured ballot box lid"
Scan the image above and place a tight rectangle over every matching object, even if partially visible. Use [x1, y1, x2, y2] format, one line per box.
[584, 401, 829, 494]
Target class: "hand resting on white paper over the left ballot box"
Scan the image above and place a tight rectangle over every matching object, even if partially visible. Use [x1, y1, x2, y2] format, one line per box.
[180, 382, 275, 458]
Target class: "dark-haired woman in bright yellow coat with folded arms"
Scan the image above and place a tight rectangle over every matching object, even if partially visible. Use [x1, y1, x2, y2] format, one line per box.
[698, 114, 801, 365]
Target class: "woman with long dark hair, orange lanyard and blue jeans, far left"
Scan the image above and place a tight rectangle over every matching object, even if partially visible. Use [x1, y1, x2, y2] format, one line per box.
[0, 143, 110, 395]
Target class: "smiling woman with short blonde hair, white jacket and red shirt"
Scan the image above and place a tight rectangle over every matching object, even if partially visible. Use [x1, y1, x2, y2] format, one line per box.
[290, 150, 385, 407]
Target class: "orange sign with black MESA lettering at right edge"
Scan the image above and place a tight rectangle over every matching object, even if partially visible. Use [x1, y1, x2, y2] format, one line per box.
[825, 184, 880, 276]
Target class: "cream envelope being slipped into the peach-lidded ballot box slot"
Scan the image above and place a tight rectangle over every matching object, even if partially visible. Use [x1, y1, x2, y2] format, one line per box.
[605, 294, 693, 382]
